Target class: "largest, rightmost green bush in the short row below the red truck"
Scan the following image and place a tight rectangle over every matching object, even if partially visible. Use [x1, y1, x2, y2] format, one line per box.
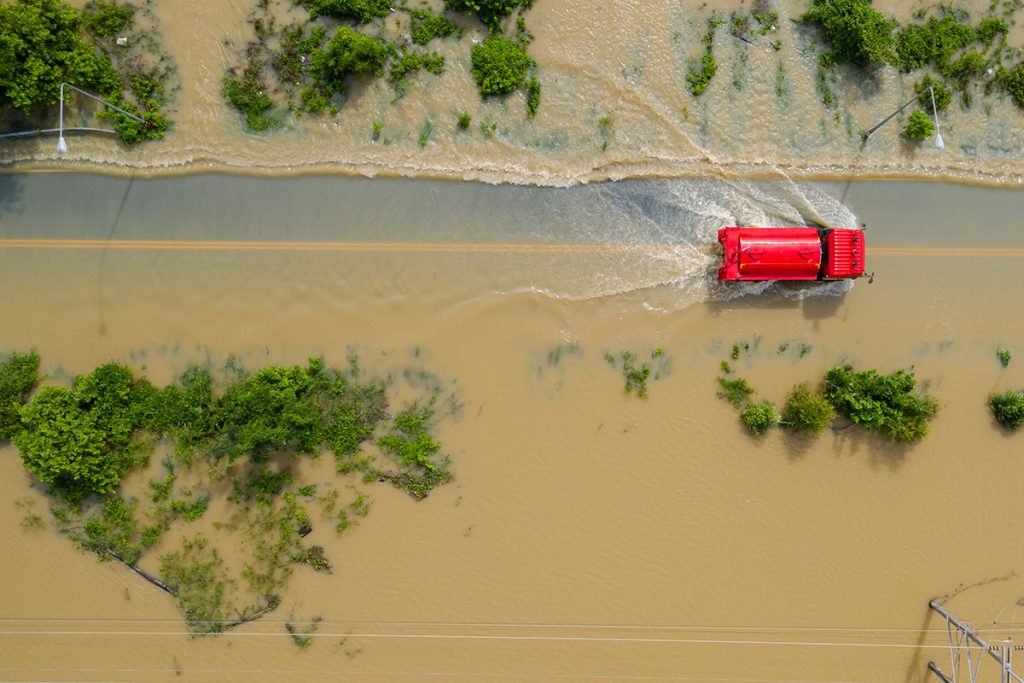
[825, 365, 939, 443]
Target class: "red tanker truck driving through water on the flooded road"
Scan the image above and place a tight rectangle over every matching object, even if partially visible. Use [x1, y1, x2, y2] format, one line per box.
[718, 227, 864, 282]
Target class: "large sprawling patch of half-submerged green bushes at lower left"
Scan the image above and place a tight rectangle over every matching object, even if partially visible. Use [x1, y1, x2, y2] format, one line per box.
[0, 353, 459, 633]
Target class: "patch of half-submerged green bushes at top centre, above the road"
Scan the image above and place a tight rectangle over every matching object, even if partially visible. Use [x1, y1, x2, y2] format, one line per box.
[223, 0, 541, 132]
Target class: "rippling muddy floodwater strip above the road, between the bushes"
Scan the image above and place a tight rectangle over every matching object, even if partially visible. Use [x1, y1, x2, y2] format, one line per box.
[0, 0, 1024, 185]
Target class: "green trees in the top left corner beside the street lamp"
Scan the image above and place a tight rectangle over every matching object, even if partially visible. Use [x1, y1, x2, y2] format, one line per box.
[0, 0, 175, 144]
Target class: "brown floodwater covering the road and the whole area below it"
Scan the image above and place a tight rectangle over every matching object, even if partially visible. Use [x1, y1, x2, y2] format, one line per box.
[0, 174, 1024, 682]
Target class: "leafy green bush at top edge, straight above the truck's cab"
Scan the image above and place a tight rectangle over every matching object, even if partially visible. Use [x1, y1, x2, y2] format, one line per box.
[800, 0, 898, 67]
